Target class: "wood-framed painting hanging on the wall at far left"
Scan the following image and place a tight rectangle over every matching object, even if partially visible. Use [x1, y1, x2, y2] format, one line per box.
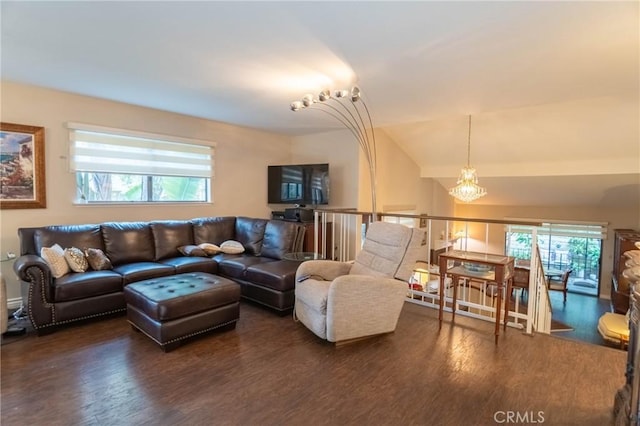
[0, 123, 47, 209]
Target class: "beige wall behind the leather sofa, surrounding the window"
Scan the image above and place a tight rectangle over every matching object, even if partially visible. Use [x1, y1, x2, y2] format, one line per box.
[0, 81, 291, 299]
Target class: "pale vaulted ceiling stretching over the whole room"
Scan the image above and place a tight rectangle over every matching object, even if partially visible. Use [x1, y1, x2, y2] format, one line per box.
[0, 1, 640, 206]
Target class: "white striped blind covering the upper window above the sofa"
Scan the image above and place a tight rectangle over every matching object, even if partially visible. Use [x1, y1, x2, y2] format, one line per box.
[67, 123, 215, 178]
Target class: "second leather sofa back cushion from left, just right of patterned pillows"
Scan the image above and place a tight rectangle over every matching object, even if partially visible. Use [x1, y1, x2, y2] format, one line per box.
[104, 222, 155, 266]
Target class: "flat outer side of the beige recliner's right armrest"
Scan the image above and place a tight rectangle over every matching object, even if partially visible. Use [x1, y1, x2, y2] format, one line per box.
[327, 275, 408, 342]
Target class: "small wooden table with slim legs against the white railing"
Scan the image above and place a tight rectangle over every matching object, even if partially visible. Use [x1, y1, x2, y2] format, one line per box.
[438, 250, 515, 344]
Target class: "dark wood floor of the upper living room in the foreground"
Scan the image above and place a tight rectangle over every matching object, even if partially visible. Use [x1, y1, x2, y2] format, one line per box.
[0, 303, 626, 426]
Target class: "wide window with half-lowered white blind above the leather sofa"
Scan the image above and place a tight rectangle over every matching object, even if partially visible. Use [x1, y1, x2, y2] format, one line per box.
[67, 123, 215, 203]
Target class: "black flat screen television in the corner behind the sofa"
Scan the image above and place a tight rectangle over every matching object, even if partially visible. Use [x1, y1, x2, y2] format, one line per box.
[267, 163, 329, 206]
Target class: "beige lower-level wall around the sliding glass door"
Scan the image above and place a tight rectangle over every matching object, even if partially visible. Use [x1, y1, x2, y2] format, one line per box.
[455, 204, 638, 298]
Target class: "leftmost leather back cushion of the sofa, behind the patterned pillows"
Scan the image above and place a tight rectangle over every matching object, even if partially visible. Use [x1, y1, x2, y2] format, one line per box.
[34, 225, 104, 253]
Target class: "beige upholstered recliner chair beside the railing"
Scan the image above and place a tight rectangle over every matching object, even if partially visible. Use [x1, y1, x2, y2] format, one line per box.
[294, 222, 426, 343]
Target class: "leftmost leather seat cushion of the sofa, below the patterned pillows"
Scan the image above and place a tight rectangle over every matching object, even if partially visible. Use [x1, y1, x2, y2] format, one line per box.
[53, 271, 123, 302]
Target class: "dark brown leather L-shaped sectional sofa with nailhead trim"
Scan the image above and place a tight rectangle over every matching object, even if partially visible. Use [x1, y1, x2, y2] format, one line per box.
[14, 216, 304, 334]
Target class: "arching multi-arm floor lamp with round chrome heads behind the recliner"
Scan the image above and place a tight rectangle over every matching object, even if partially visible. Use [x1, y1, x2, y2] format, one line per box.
[290, 86, 377, 221]
